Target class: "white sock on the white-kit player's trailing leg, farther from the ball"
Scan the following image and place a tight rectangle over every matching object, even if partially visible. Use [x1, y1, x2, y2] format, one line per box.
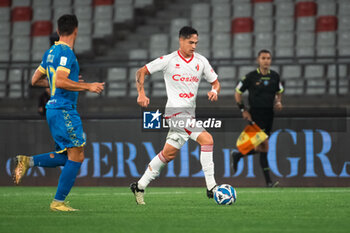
[137, 151, 169, 189]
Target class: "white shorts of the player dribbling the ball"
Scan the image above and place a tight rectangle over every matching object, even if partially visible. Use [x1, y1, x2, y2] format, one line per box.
[166, 113, 205, 149]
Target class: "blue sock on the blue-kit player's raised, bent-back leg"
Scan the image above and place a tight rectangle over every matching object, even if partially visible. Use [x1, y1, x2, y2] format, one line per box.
[32, 152, 68, 167]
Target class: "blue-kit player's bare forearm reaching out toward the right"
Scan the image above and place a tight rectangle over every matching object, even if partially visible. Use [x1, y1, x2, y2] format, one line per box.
[56, 70, 105, 94]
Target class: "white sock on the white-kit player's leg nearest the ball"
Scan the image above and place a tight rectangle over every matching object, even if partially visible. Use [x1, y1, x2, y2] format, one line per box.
[200, 145, 216, 190]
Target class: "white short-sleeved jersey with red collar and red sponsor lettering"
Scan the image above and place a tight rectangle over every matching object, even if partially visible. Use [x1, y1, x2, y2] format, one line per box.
[146, 51, 218, 116]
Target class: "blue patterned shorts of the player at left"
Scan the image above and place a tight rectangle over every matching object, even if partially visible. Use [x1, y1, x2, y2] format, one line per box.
[46, 108, 86, 153]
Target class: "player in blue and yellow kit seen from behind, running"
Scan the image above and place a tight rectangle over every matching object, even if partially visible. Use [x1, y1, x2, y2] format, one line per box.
[13, 15, 104, 211]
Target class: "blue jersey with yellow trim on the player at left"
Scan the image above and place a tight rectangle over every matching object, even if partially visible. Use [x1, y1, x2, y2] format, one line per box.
[38, 41, 79, 109]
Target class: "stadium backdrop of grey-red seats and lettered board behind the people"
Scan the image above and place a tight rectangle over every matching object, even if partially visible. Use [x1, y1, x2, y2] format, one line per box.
[0, 0, 350, 187]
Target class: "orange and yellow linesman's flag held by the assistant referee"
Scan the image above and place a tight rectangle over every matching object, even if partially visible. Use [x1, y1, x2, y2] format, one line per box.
[236, 122, 268, 155]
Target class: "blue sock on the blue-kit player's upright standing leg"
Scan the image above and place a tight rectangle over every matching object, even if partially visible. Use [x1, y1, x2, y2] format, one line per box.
[55, 160, 81, 201]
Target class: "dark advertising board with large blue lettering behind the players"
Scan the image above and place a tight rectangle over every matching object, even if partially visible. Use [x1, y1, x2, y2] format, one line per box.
[0, 117, 350, 187]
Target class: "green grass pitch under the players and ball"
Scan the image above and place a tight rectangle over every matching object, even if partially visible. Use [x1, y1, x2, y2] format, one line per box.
[0, 187, 350, 233]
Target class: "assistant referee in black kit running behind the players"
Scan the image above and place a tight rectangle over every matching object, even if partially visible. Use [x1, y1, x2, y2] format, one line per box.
[232, 49, 284, 187]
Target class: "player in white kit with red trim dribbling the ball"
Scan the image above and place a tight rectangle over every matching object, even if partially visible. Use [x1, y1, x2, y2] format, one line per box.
[130, 26, 220, 205]
